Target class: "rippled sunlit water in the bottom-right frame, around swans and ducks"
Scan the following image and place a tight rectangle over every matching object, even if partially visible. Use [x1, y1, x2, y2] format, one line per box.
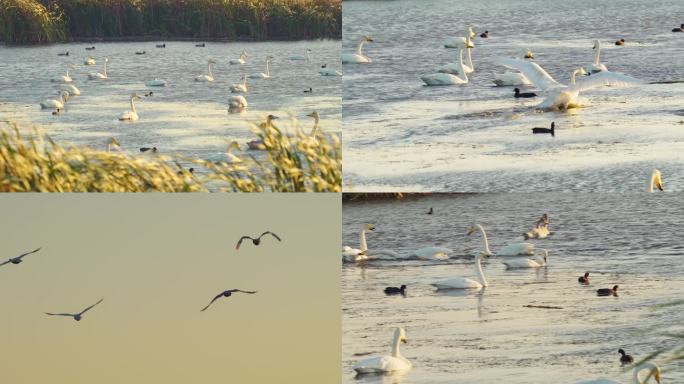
[342, 193, 684, 384]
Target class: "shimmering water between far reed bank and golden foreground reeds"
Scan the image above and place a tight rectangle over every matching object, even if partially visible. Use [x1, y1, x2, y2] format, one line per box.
[0, 41, 341, 170]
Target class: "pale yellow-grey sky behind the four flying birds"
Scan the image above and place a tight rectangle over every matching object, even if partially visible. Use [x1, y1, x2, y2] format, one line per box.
[0, 194, 341, 384]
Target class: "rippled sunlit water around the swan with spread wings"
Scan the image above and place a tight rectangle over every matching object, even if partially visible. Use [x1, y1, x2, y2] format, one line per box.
[343, 0, 684, 192]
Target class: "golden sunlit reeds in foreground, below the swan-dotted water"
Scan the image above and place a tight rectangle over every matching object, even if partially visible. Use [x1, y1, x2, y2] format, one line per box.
[0, 120, 342, 192]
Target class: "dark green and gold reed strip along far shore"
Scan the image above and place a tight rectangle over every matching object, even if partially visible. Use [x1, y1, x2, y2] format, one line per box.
[0, 0, 342, 44]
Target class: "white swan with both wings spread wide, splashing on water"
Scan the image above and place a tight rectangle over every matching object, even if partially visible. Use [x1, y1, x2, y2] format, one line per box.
[498, 59, 640, 111]
